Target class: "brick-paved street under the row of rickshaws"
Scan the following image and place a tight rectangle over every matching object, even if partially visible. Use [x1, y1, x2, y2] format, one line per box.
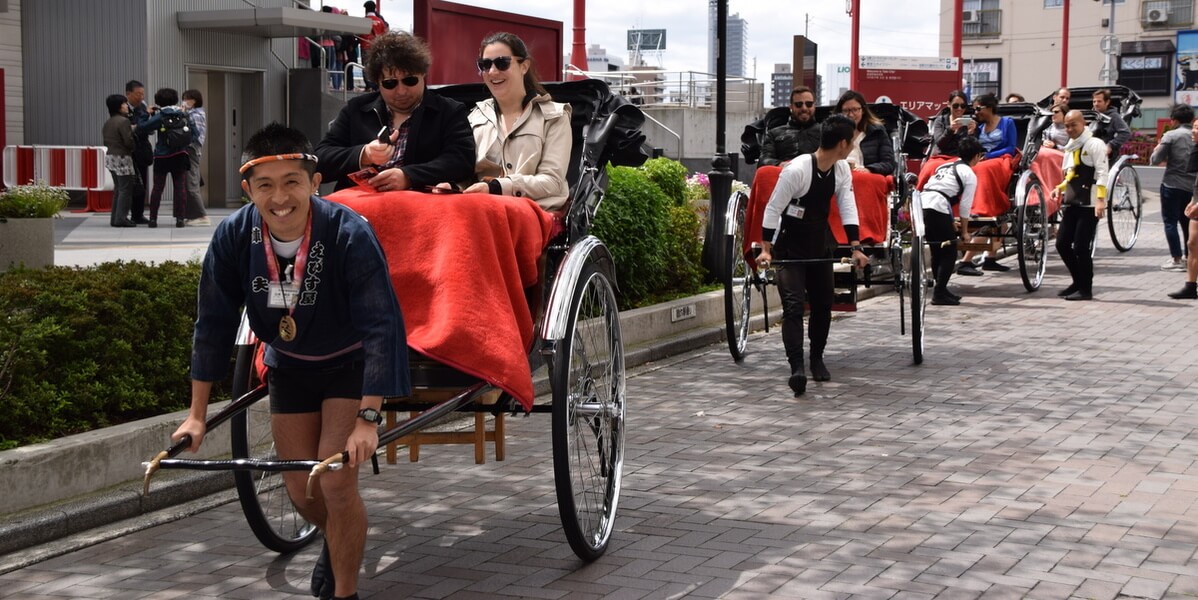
[0, 205, 1198, 600]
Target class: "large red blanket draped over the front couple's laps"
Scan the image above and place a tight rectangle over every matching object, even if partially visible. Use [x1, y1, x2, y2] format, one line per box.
[328, 188, 552, 410]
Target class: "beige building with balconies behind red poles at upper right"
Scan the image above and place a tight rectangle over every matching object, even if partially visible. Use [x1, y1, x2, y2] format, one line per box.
[940, 0, 1198, 127]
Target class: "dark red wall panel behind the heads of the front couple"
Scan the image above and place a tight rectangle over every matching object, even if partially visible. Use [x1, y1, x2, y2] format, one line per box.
[412, 0, 565, 85]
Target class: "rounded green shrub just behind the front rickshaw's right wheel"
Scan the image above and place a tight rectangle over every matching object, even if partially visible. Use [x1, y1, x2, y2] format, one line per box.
[592, 166, 670, 309]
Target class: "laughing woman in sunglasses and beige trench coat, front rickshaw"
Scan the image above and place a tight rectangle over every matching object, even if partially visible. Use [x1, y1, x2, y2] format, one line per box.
[452, 31, 571, 211]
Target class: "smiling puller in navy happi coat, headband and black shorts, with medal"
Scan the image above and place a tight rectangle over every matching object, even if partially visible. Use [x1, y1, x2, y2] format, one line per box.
[173, 123, 411, 599]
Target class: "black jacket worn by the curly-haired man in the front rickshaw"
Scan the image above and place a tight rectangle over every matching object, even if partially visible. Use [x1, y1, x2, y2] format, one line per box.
[316, 90, 474, 189]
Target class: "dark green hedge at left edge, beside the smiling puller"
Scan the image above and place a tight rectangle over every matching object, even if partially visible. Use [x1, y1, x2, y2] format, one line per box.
[0, 262, 200, 449]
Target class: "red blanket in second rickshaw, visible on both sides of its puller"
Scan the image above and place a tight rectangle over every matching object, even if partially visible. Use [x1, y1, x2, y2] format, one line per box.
[744, 165, 894, 258]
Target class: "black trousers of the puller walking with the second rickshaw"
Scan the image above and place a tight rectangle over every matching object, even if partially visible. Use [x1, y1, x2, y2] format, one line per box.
[778, 262, 835, 372]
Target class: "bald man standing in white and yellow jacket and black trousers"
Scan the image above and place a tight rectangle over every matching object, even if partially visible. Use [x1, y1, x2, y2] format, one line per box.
[1052, 110, 1107, 301]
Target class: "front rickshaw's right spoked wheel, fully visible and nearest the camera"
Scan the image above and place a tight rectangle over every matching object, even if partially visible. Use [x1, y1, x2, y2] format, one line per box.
[551, 263, 624, 562]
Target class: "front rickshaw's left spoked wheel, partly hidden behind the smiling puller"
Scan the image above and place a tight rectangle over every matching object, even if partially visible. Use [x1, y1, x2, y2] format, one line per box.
[230, 345, 316, 553]
